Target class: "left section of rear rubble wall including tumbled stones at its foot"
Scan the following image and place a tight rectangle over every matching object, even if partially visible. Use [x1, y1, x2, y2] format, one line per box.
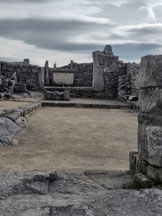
[0, 59, 41, 98]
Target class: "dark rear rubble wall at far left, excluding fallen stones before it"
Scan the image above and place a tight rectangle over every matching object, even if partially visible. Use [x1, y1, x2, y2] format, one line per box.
[0, 62, 41, 91]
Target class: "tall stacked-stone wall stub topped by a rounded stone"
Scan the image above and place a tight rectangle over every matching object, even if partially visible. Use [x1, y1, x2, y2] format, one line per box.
[93, 45, 119, 98]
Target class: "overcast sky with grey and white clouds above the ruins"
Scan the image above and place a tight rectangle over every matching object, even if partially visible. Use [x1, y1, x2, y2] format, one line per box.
[0, 0, 162, 66]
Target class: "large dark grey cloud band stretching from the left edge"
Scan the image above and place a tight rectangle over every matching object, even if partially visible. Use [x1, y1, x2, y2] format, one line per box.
[0, 18, 112, 52]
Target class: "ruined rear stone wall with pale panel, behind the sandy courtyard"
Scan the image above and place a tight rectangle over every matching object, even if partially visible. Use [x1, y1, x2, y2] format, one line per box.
[0, 45, 139, 100]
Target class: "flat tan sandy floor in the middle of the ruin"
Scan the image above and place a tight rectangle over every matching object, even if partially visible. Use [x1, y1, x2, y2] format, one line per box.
[0, 108, 137, 171]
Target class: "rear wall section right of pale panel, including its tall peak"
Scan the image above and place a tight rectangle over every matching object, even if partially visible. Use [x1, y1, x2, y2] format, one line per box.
[93, 45, 139, 99]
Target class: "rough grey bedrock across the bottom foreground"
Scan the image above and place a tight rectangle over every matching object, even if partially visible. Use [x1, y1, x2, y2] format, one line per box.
[0, 172, 162, 216]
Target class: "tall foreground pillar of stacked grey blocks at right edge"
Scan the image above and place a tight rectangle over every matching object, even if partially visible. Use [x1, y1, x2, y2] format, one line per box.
[138, 55, 162, 182]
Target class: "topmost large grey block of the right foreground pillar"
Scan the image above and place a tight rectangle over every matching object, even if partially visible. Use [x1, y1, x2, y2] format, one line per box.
[139, 55, 162, 87]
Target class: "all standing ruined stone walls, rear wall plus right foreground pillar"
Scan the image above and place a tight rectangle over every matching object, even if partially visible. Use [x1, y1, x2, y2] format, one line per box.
[0, 45, 162, 182]
